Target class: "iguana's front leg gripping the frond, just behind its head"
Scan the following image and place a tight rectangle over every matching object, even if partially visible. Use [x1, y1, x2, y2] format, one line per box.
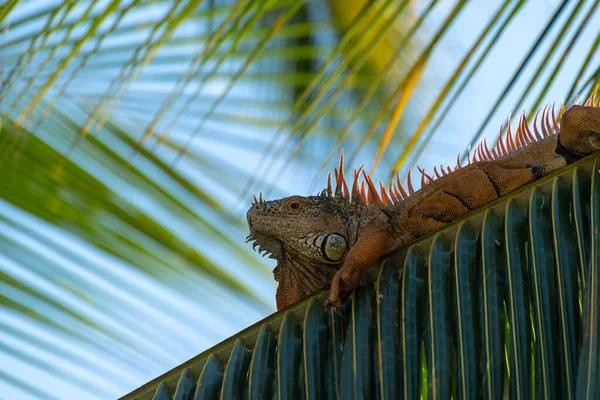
[327, 218, 392, 310]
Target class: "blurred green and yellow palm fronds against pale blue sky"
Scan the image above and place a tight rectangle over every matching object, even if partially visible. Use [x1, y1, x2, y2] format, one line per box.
[0, 0, 600, 399]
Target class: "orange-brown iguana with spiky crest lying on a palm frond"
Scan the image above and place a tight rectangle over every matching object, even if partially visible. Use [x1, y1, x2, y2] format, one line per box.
[247, 102, 600, 310]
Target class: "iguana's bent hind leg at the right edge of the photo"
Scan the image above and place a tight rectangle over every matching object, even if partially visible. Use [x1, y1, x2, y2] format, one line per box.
[558, 106, 600, 157]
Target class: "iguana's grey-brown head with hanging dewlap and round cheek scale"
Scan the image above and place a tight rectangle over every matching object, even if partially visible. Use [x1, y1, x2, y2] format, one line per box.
[247, 153, 392, 309]
